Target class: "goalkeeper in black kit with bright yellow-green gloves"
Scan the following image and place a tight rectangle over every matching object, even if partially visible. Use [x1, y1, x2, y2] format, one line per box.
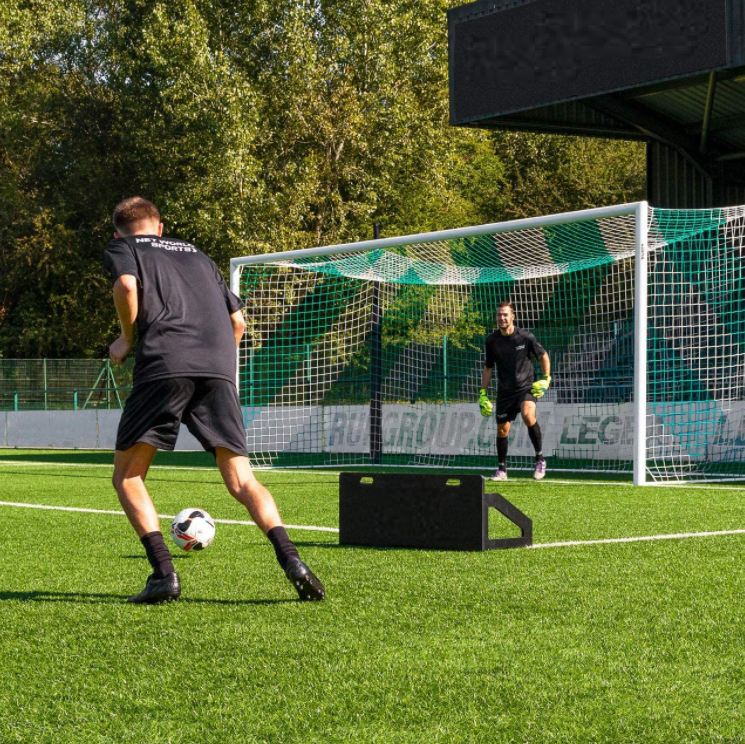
[479, 302, 551, 481]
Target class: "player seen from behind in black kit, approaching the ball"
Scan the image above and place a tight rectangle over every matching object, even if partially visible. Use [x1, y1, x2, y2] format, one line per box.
[104, 197, 325, 604]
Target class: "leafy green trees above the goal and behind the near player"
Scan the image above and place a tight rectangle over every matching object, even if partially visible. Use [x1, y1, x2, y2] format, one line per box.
[0, 0, 643, 357]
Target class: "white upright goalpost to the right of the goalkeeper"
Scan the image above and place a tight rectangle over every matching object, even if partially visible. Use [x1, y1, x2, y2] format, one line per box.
[634, 202, 648, 486]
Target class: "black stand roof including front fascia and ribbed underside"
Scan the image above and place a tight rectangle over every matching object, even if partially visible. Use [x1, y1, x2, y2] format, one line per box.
[448, 0, 745, 185]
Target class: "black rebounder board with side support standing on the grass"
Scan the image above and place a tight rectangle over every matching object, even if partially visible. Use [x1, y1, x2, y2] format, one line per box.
[339, 473, 533, 550]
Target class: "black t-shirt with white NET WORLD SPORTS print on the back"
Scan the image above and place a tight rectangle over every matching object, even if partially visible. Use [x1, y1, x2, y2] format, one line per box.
[103, 235, 243, 384]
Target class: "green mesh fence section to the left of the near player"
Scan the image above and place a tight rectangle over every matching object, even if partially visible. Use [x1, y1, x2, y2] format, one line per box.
[0, 359, 134, 411]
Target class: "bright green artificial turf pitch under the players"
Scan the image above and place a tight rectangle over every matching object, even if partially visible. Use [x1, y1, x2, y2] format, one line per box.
[0, 450, 745, 744]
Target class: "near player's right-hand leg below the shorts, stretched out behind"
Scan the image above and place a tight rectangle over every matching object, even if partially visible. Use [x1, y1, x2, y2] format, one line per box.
[214, 447, 326, 601]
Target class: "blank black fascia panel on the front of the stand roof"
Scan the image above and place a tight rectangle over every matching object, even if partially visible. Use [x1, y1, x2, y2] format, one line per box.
[449, 0, 727, 124]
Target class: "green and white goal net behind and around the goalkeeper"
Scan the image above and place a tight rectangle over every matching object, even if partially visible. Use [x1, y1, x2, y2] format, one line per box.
[231, 205, 745, 481]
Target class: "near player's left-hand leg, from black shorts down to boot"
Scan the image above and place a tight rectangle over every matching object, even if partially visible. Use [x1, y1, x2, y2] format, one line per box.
[113, 378, 192, 604]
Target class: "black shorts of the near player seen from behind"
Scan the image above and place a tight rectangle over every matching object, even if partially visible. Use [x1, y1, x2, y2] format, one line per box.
[116, 377, 248, 455]
